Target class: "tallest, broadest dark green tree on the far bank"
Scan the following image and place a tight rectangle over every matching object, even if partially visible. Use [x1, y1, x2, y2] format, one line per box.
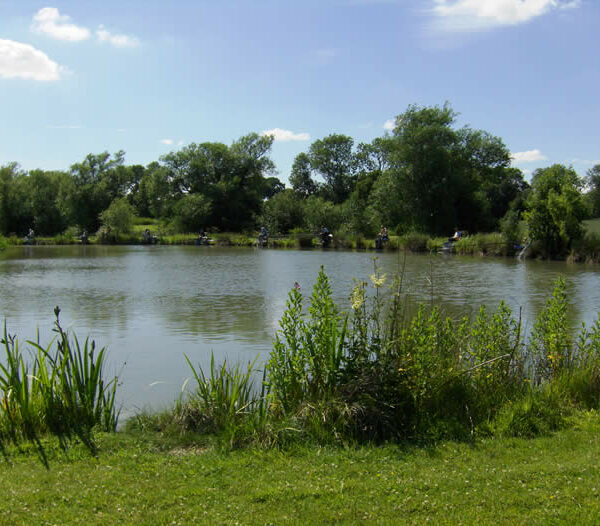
[371, 104, 523, 235]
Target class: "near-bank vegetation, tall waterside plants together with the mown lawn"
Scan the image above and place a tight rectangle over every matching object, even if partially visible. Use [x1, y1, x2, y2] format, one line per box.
[0, 266, 600, 524]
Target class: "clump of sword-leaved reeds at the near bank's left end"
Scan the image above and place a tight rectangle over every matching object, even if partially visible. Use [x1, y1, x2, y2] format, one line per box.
[0, 307, 118, 454]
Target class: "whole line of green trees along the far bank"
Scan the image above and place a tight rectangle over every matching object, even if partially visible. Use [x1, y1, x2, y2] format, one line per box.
[0, 103, 600, 252]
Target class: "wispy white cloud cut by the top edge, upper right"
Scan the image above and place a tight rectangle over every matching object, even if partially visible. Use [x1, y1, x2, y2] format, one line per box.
[431, 0, 581, 31]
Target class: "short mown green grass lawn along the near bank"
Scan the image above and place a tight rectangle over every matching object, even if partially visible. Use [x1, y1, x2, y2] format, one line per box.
[0, 413, 600, 525]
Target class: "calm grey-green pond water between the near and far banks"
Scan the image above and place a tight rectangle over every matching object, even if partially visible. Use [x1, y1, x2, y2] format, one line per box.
[0, 246, 600, 417]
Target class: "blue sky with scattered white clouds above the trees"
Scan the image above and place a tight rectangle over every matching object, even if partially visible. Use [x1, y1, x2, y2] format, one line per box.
[0, 0, 600, 182]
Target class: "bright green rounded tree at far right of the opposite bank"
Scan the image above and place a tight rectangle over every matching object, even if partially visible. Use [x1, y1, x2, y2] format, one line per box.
[524, 164, 586, 256]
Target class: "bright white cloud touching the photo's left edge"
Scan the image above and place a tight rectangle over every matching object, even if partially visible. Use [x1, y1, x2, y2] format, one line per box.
[0, 39, 64, 81]
